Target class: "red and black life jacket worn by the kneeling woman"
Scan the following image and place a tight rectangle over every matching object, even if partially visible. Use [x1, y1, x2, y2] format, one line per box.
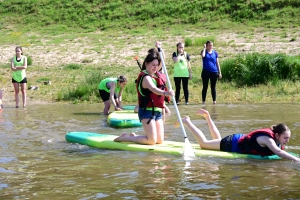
[136, 70, 166, 109]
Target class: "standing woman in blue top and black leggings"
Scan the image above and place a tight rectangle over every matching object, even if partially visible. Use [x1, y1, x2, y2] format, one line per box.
[200, 41, 222, 104]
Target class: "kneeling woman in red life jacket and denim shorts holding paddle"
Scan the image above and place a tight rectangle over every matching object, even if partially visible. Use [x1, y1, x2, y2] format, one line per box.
[115, 54, 174, 145]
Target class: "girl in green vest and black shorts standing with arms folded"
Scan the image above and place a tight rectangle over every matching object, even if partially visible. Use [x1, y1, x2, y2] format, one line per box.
[11, 47, 27, 108]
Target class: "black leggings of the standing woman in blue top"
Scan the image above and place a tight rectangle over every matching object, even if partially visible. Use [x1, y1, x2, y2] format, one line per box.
[201, 70, 219, 102]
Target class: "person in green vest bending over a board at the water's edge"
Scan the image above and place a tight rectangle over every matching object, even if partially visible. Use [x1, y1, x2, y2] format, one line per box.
[98, 76, 127, 115]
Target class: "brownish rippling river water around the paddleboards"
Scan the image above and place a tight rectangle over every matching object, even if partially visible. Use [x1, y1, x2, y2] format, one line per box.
[0, 104, 300, 200]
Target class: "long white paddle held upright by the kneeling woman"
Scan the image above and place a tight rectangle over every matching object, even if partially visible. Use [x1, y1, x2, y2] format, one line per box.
[158, 48, 195, 157]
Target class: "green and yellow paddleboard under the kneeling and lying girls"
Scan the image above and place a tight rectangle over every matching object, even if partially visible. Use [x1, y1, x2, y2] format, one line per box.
[65, 132, 297, 160]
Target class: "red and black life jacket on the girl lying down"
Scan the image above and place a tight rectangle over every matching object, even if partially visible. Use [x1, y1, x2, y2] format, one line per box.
[238, 128, 284, 156]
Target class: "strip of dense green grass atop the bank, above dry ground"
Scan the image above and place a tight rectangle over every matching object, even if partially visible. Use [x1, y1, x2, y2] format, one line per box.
[0, 0, 300, 32]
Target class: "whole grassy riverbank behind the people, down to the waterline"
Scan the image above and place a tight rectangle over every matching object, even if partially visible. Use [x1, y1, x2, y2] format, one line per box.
[0, 0, 300, 103]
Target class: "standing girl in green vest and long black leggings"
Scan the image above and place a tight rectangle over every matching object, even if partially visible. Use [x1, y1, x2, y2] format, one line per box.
[172, 42, 192, 105]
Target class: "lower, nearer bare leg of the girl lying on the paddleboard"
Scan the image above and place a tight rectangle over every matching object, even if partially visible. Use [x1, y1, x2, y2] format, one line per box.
[175, 116, 221, 150]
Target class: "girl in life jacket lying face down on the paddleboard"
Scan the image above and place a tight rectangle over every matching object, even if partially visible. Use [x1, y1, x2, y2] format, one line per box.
[175, 109, 300, 162]
